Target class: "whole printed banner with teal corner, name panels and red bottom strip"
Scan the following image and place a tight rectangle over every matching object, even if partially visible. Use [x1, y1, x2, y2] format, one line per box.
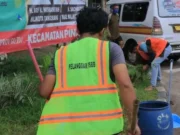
[0, 0, 85, 54]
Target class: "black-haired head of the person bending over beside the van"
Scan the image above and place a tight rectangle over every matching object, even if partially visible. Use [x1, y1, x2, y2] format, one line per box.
[123, 41, 137, 64]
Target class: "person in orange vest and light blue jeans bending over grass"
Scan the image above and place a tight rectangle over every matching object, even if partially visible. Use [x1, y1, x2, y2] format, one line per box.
[137, 38, 172, 90]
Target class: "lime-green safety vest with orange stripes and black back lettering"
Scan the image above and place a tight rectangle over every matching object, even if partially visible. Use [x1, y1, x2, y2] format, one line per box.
[37, 38, 124, 135]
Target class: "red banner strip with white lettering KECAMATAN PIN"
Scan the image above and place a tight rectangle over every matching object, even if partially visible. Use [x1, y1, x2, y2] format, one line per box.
[0, 25, 77, 54]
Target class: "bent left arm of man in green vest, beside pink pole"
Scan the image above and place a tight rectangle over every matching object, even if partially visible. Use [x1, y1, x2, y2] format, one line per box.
[39, 59, 56, 99]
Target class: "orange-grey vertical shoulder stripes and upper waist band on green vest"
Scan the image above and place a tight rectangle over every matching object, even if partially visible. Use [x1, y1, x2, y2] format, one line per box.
[51, 40, 117, 98]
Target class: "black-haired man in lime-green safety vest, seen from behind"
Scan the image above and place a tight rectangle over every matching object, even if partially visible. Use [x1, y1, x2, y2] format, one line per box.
[37, 8, 140, 135]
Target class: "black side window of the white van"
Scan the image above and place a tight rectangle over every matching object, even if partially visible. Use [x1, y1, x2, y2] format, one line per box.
[122, 2, 149, 22]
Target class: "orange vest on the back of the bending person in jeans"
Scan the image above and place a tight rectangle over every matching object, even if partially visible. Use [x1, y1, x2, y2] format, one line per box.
[146, 38, 167, 57]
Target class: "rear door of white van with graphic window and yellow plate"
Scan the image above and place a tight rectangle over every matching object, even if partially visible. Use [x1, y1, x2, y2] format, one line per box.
[157, 0, 180, 53]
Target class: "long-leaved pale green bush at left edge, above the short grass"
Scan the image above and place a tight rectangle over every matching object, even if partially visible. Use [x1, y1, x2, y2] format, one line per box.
[0, 74, 38, 108]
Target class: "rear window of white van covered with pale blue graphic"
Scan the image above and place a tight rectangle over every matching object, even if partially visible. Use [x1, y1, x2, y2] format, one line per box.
[158, 0, 180, 17]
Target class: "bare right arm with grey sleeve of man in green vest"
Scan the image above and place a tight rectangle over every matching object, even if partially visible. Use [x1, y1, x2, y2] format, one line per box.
[110, 43, 136, 121]
